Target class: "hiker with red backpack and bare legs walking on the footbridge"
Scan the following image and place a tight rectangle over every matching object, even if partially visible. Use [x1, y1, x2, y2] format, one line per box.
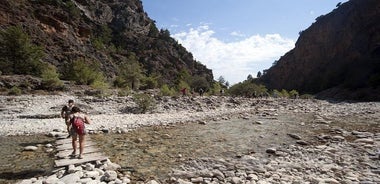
[67, 107, 91, 159]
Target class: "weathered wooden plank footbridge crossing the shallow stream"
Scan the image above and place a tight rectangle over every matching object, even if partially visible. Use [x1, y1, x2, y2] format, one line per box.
[55, 136, 108, 167]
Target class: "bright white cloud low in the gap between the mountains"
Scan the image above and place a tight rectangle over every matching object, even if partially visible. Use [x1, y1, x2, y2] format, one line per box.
[172, 25, 294, 84]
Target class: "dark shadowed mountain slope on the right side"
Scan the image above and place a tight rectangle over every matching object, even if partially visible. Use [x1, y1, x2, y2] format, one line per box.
[260, 0, 380, 100]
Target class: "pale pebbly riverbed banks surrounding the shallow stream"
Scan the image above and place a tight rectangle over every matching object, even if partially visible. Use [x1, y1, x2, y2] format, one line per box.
[0, 94, 380, 184]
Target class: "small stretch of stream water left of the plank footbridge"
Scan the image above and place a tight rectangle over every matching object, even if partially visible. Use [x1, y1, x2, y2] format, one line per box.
[0, 135, 55, 183]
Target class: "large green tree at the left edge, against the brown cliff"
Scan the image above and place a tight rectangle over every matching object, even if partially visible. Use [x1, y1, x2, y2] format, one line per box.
[0, 26, 45, 76]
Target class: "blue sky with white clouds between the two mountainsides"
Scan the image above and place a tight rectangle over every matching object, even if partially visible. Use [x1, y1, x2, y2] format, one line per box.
[142, 0, 347, 84]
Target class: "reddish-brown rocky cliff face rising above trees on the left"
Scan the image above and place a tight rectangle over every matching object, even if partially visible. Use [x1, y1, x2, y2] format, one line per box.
[0, 0, 213, 83]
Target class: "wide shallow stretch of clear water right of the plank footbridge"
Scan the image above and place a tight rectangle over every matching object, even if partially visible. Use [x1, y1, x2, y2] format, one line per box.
[92, 114, 308, 181]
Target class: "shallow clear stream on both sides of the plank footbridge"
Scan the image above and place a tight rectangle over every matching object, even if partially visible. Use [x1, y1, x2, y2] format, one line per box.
[0, 115, 310, 183]
